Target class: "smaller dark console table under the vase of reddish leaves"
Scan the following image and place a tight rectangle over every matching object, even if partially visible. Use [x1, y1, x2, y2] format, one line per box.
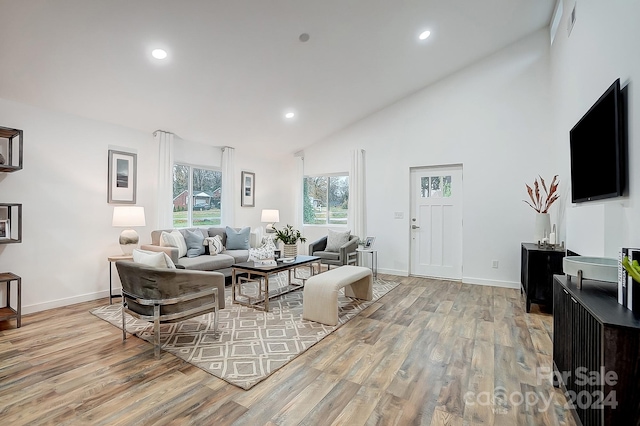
[520, 243, 565, 312]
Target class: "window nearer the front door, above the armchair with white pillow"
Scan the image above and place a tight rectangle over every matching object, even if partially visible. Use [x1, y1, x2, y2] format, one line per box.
[303, 175, 349, 225]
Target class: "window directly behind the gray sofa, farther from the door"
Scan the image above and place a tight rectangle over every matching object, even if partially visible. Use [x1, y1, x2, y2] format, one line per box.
[173, 164, 222, 228]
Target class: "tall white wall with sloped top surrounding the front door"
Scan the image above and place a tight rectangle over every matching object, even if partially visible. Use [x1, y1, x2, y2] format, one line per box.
[305, 30, 558, 287]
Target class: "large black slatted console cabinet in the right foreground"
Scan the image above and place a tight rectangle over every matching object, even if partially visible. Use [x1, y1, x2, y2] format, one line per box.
[553, 275, 640, 426]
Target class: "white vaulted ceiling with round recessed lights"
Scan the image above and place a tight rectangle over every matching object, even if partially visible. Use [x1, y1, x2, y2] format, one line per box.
[0, 0, 554, 153]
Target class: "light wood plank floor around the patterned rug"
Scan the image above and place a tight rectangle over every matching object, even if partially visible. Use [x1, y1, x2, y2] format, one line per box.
[0, 276, 574, 426]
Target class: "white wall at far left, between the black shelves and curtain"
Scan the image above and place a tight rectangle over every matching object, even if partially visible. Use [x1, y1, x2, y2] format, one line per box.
[0, 99, 157, 313]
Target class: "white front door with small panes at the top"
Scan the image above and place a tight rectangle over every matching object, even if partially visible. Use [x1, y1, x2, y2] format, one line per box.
[409, 165, 462, 280]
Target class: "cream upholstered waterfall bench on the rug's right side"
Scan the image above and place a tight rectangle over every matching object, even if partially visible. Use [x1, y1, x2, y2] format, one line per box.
[302, 265, 373, 325]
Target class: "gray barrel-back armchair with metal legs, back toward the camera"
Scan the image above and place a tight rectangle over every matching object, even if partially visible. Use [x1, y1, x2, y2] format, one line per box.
[116, 260, 225, 358]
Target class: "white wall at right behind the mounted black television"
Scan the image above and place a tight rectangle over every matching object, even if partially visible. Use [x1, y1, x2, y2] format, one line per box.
[551, 0, 640, 258]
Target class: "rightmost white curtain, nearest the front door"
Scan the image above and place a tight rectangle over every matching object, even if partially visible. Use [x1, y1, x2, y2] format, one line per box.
[348, 149, 367, 239]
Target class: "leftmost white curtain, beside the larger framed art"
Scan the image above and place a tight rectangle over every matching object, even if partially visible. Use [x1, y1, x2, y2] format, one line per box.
[153, 130, 173, 229]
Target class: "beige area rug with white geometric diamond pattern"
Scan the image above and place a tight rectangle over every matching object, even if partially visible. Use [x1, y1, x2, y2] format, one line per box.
[91, 273, 398, 389]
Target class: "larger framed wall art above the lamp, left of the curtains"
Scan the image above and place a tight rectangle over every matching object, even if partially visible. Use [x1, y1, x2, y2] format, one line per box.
[107, 149, 138, 204]
